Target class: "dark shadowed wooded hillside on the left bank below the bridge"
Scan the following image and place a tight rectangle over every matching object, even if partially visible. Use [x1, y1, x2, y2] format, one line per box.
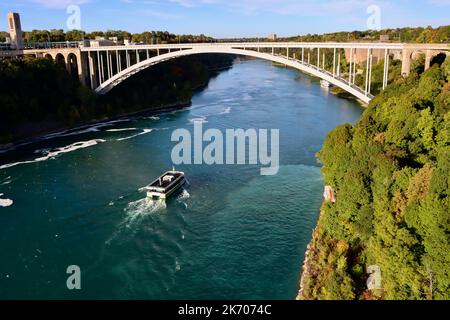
[0, 55, 234, 144]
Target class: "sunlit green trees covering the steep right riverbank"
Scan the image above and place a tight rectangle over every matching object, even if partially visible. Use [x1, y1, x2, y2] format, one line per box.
[304, 56, 450, 299]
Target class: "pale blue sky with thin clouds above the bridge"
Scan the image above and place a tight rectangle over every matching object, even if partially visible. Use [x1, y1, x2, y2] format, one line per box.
[0, 0, 450, 37]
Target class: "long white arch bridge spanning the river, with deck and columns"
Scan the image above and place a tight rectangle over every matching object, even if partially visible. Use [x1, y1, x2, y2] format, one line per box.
[12, 42, 450, 103]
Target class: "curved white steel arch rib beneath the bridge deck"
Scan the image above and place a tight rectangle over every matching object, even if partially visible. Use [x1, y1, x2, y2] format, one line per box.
[95, 46, 373, 103]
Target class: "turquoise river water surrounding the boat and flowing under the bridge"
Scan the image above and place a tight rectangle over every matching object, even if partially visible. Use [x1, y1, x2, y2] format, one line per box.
[0, 61, 362, 299]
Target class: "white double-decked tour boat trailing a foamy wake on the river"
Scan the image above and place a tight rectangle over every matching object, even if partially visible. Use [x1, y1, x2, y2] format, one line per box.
[146, 168, 186, 200]
